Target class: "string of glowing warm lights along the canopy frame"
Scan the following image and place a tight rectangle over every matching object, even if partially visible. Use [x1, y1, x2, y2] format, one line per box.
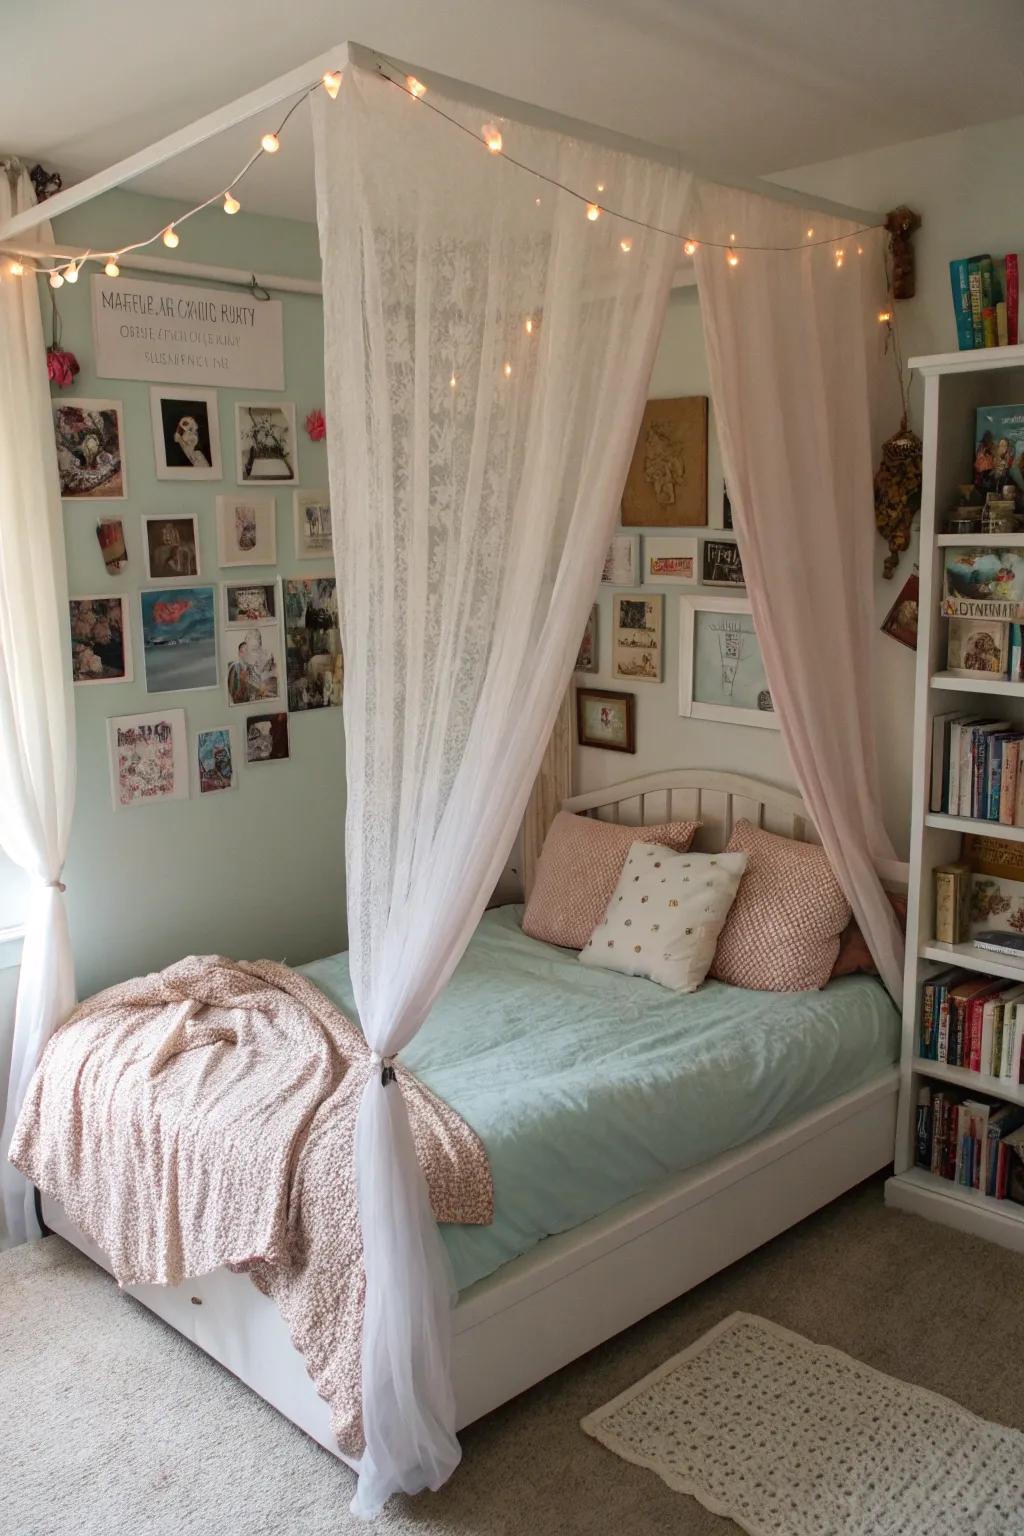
[0, 58, 884, 287]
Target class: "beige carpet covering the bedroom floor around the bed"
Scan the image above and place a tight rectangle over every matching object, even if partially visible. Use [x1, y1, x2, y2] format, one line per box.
[0, 1181, 1024, 1536]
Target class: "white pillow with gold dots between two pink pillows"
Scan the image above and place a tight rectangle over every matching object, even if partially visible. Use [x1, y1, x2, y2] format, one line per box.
[580, 843, 746, 992]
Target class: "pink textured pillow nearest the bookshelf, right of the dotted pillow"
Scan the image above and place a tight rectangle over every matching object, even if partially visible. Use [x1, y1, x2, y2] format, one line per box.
[711, 822, 852, 992]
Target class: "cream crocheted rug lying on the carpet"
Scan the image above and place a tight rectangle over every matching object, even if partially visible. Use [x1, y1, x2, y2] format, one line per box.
[582, 1312, 1024, 1536]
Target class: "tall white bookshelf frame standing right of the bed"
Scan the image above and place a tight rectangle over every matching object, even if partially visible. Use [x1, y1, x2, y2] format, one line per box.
[886, 346, 1024, 1252]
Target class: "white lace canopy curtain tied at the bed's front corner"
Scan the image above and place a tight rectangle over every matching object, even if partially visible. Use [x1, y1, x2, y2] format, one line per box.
[313, 69, 689, 1514]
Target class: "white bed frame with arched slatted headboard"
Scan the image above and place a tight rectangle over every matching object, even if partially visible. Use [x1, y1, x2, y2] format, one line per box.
[43, 770, 906, 1465]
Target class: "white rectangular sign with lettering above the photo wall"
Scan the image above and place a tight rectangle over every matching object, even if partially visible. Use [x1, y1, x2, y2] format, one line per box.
[92, 275, 284, 389]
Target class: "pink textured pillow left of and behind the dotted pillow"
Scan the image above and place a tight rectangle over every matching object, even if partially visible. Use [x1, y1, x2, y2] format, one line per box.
[522, 811, 700, 949]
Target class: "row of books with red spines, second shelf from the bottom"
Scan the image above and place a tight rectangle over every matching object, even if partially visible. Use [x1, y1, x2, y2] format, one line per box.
[918, 969, 1024, 1086]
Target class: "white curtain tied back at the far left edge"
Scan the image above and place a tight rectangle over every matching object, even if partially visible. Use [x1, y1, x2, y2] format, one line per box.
[0, 161, 75, 1243]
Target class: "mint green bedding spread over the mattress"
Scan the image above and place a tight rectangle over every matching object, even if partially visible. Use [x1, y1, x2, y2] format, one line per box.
[301, 906, 900, 1290]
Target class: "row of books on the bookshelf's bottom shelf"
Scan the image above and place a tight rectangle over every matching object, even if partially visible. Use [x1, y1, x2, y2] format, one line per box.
[915, 1087, 1024, 1204]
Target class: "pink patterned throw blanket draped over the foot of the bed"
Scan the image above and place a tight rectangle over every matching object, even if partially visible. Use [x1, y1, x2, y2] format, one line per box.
[11, 955, 494, 1456]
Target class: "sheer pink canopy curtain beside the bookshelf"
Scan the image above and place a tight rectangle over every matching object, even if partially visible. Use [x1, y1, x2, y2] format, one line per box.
[692, 183, 903, 997]
